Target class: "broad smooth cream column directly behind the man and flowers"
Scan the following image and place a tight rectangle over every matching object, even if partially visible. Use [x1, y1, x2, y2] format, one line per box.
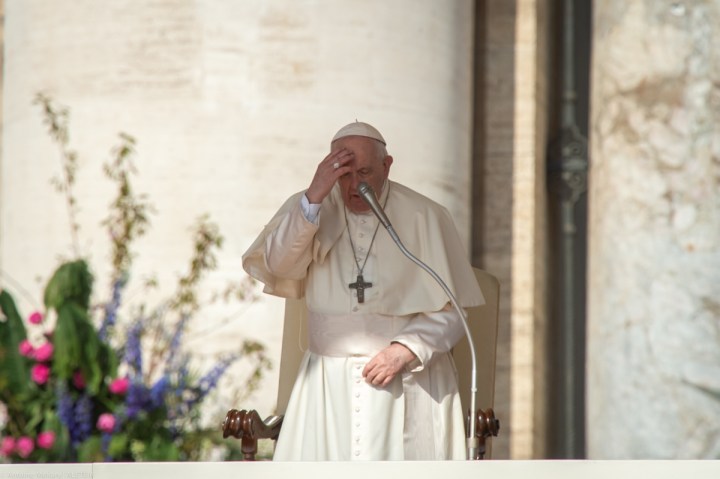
[0, 0, 474, 432]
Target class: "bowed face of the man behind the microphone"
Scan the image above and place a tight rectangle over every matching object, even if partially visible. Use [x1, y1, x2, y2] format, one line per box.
[331, 136, 392, 213]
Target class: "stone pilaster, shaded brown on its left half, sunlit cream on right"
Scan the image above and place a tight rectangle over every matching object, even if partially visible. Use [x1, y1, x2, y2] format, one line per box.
[476, 0, 548, 459]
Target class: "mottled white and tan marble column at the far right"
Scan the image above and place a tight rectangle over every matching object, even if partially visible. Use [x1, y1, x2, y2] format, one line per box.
[587, 0, 720, 459]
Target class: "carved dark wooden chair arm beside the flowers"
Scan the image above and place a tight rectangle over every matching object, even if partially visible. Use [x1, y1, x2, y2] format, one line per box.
[222, 409, 283, 461]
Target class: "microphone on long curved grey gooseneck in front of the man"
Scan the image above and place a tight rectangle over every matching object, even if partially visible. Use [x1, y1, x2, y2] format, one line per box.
[358, 181, 480, 460]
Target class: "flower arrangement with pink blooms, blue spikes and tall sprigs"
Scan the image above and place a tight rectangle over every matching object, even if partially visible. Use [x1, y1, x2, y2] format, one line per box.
[0, 95, 270, 462]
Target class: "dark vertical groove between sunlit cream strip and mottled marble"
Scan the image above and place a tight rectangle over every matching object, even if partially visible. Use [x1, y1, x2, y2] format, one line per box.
[545, 0, 592, 459]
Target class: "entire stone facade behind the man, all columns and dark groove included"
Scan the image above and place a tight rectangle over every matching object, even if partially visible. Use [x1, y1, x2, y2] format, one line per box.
[0, 0, 720, 459]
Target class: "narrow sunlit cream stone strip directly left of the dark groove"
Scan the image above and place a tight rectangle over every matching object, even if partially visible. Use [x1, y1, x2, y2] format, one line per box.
[510, 0, 548, 459]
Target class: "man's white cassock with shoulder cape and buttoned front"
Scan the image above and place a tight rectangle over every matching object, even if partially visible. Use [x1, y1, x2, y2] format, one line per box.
[243, 181, 484, 460]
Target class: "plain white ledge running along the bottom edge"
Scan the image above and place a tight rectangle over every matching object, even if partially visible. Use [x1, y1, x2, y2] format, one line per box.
[0, 460, 720, 479]
